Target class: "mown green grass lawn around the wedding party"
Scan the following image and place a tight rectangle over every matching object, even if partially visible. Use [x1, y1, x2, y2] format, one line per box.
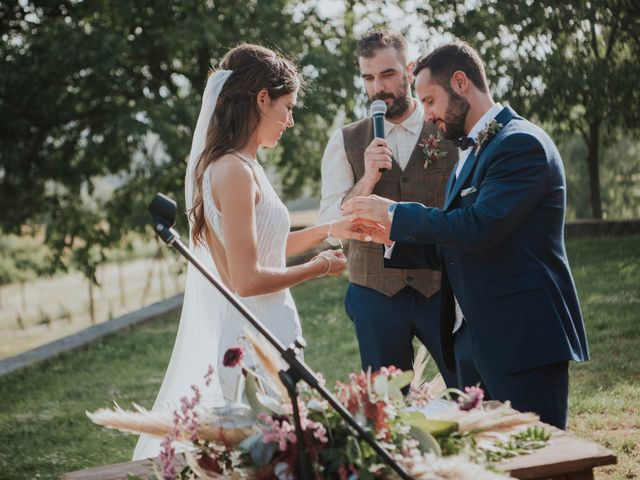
[0, 235, 640, 480]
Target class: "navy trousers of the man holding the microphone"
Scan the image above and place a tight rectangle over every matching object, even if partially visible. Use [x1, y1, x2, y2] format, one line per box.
[345, 283, 457, 387]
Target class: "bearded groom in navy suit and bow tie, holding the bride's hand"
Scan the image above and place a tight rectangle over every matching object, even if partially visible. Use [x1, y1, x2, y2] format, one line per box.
[344, 42, 589, 428]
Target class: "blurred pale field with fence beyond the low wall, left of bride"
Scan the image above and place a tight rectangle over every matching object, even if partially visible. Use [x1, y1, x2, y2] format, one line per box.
[0, 211, 317, 359]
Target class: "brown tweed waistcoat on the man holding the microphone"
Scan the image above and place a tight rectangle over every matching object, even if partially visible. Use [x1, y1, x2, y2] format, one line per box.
[342, 118, 458, 297]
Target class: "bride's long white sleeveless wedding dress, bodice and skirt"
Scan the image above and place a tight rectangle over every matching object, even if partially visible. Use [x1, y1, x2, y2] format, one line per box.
[133, 154, 302, 460]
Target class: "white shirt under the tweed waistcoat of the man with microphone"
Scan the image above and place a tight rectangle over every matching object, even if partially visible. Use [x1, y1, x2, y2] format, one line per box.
[319, 99, 424, 223]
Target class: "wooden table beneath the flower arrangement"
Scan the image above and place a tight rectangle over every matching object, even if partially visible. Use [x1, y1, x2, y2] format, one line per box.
[61, 427, 617, 480]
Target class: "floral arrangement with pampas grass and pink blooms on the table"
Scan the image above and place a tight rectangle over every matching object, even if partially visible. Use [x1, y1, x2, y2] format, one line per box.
[87, 332, 550, 480]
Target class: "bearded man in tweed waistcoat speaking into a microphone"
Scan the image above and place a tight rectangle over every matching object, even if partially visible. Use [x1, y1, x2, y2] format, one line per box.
[320, 29, 457, 386]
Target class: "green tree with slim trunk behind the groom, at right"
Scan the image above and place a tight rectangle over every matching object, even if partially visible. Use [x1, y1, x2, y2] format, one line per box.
[418, 0, 640, 218]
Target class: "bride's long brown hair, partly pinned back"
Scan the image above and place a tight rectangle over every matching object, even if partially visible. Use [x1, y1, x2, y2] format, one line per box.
[188, 43, 301, 244]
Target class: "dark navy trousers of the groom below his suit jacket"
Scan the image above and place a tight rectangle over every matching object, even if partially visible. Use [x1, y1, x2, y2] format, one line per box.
[454, 322, 569, 430]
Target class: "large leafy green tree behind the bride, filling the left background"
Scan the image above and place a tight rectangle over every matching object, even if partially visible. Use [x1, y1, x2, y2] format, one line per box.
[0, 0, 364, 277]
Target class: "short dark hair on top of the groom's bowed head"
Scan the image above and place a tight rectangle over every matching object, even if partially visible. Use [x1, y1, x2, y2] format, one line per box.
[413, 40, 489, 93]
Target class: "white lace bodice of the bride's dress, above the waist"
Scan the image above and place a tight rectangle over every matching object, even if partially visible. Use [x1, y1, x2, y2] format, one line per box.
[202, 153, 291, 268]
